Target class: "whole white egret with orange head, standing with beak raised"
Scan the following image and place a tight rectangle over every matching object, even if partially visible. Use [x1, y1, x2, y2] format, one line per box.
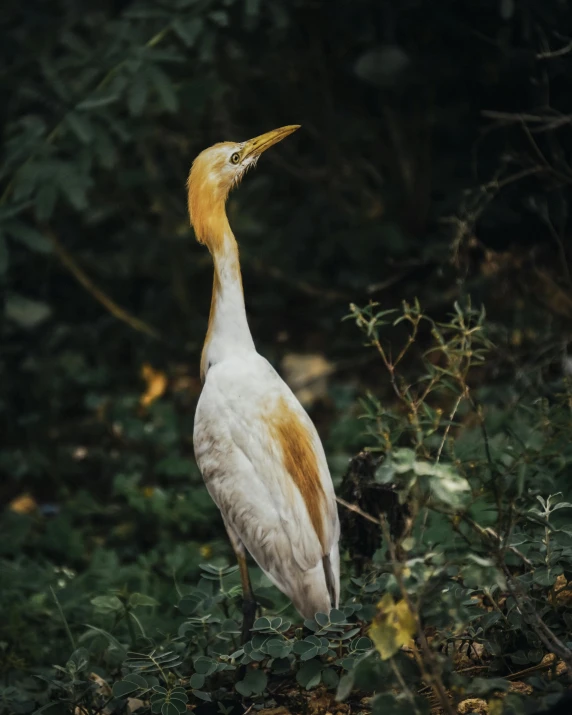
[187, 125, 340, 642]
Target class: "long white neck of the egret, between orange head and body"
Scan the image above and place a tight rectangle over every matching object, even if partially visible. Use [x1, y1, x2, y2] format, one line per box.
[201, 216, 255, 381]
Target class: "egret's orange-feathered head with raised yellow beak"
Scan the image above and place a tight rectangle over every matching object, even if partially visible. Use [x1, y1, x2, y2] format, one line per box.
[187, 124, 300, 249]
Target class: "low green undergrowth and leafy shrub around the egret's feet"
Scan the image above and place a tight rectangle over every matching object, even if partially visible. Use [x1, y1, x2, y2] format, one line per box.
[0, 303, 572, 715]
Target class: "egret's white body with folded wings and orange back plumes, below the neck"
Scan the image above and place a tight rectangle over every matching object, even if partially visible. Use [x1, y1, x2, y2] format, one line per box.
[194, 354, 339, 615]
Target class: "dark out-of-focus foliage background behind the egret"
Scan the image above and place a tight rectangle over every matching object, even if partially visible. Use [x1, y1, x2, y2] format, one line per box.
[0, 0, 572, 715]
